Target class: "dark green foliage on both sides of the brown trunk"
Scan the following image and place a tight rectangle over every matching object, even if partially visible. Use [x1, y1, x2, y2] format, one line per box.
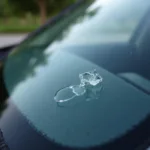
[5, 0, 76, 16]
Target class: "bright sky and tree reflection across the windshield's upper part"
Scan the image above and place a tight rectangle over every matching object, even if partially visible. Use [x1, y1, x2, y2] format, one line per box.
[19, 0, 149, 45]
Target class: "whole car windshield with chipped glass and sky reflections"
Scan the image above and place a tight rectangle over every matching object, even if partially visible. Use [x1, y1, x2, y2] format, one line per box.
[4, 0, 150, 150]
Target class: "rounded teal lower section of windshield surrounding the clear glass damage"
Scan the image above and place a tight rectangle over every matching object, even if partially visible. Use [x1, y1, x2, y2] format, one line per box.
[4, 52, 150, 148]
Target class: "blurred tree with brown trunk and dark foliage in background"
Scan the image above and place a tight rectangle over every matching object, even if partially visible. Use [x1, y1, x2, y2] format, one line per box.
[6, 0, 76, 24]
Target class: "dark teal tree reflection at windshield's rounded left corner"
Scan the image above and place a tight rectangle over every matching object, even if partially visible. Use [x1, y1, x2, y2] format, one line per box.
[5, 46, 48, 91]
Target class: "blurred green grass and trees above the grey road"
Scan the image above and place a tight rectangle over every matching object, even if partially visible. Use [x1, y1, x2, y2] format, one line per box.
[0, 0, 76, 33]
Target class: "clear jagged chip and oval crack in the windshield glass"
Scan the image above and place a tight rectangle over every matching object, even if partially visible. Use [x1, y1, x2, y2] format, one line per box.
[54, 69, 103, 103]
